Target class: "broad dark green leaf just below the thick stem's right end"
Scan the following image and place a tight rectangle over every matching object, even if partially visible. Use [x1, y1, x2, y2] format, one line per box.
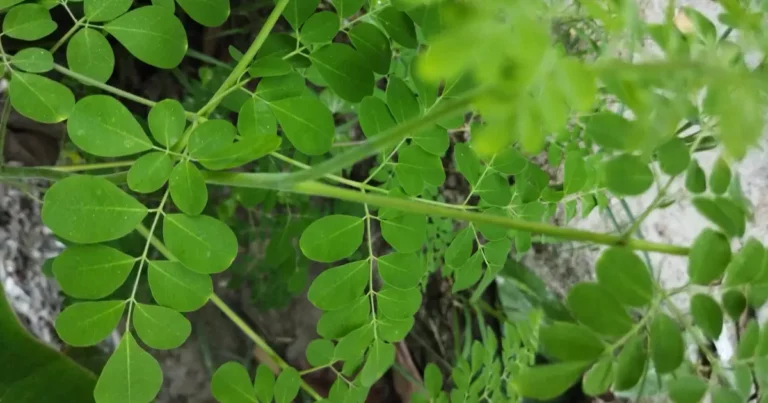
[596, 247, 653, 307]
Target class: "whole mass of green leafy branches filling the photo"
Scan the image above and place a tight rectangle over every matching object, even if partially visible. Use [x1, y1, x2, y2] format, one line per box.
[0, 0, 768, 403]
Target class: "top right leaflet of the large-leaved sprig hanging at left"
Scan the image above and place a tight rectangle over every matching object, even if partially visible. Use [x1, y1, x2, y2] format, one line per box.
[163, 214, 237, 274]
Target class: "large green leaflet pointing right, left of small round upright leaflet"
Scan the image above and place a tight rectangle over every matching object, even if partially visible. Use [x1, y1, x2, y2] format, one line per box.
[67, 95, 152, 157]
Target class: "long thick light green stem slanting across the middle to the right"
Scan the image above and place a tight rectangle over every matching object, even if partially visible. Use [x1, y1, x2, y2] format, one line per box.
[205, 177, 689, 256]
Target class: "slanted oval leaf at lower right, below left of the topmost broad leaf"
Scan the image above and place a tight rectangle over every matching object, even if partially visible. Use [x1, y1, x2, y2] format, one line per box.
[567, 283, 632, 336]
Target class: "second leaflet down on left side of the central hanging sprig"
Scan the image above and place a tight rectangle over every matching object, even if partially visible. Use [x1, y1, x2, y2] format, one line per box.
[307, 260, 370, 311]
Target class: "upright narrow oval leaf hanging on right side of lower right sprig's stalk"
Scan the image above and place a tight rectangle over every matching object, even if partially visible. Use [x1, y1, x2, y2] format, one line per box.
[651, 314, 685, 374]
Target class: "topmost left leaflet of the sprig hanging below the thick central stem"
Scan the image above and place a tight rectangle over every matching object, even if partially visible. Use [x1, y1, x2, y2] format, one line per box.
[299, 215, 364, 263]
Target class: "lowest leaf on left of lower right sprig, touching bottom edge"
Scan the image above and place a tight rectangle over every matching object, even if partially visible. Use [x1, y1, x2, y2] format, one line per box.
[512, 361, 590, 400]
